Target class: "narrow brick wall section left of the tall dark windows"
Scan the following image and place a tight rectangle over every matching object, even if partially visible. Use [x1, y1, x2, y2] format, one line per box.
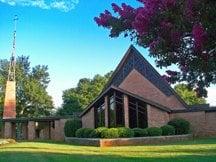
[82, 108, 95, 128]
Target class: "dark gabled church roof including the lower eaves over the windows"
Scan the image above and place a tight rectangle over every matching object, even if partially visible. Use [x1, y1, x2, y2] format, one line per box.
[81, 45, 188, 116]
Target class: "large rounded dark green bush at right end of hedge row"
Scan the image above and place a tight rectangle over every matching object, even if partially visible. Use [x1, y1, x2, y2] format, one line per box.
[168, 119, 190, 135]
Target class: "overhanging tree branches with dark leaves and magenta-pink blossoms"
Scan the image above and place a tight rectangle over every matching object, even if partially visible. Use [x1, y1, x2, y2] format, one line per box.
[94, 0, 216, 97]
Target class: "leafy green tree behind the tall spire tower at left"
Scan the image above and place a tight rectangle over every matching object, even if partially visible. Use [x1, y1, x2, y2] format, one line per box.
[0, 56, 54, 117]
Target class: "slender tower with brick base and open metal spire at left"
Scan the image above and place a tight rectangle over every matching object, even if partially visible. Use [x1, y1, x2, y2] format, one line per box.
[3, 15, 18, 119]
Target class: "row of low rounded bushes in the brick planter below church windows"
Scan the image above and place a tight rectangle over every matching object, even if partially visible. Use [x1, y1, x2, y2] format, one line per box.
[75, 119, 190, 138]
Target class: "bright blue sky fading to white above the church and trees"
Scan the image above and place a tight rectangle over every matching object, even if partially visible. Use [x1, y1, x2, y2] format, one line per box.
[0, 0, 216, 106]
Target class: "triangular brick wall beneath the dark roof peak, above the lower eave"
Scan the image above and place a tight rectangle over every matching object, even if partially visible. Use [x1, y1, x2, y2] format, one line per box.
[119, 70, 184, 109]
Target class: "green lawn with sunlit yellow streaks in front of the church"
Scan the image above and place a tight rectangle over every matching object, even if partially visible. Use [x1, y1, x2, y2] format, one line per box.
[0, 138, 216, 162]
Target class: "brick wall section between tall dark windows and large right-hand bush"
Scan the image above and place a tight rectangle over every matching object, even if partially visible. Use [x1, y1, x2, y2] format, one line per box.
[147, 105, 169, 127]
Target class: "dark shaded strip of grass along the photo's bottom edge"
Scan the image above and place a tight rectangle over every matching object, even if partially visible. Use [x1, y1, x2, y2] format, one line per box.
[0, 151, 216, 162]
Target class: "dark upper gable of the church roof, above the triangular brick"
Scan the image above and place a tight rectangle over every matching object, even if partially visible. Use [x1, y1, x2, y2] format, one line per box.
[104, 45, 188, 108]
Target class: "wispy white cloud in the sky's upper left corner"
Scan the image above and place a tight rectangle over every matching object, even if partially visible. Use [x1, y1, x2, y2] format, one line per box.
[0, 0, 79, 12]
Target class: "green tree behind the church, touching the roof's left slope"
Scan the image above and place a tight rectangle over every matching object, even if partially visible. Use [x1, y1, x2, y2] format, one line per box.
[57, 72, 112, 116]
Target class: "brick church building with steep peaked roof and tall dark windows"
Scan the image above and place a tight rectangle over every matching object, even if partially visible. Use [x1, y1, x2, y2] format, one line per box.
[81, 46, 216, 135]
